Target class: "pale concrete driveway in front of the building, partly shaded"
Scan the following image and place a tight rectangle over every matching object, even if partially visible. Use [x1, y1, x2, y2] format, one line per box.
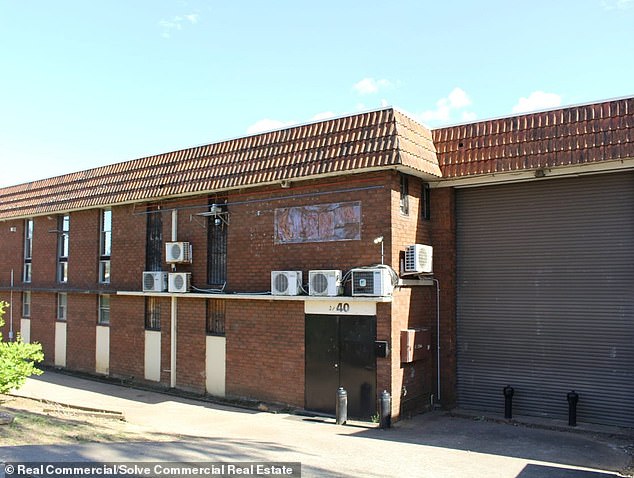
[0, 371, 634, 478]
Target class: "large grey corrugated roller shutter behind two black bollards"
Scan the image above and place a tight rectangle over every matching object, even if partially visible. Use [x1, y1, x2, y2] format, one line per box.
[457, 173, 634, 427]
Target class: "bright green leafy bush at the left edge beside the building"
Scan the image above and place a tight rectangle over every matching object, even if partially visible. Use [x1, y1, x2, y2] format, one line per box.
[0, 301, 44, 393]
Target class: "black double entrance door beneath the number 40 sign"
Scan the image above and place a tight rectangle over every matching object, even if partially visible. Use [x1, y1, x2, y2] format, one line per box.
[305, 314, 376, 420]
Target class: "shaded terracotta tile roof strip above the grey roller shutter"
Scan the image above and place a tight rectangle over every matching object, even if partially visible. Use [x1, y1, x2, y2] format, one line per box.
[432, 98, 634, 178]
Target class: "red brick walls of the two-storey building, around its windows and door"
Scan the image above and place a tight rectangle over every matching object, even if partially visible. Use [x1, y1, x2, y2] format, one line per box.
[0, 171, 455, 417]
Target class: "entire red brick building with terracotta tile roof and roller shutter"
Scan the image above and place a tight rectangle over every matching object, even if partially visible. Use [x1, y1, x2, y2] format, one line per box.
[0, 98, 634, 426]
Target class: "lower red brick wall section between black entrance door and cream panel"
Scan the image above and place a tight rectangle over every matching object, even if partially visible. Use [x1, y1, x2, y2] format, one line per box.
[225, 300, 304, 407]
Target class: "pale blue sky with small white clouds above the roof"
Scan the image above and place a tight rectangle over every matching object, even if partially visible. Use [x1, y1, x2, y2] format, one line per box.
[0, 0, 634, 187]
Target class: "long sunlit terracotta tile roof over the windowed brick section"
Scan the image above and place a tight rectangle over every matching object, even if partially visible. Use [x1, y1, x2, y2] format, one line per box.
[0, 108, 440, 219]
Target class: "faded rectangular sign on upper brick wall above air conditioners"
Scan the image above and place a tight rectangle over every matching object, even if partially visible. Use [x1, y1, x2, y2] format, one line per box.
[275, 201, 361, 244]
